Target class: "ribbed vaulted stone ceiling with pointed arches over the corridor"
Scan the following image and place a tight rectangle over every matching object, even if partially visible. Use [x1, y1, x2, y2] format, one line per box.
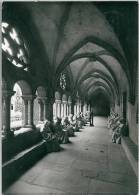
[3, 2, 137, 103]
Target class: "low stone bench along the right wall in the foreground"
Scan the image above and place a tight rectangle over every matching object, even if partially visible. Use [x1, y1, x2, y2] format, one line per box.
[121, 137, 138, 177]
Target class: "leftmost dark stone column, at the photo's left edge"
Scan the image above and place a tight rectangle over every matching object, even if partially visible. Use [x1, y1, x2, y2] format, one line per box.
[2, 91, 15, 138]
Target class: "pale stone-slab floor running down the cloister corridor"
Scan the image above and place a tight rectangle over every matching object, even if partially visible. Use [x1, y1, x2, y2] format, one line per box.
[4, 117, 137, 195]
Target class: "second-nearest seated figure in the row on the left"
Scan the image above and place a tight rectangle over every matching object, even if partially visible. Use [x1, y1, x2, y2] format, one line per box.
[54, 117, 69, 144]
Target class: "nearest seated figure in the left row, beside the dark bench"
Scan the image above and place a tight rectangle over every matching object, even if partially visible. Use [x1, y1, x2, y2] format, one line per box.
[40, 120, 60, 152]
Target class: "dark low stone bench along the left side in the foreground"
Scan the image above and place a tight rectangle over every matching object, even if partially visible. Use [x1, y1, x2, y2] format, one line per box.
[2, 140, 47, 190]
